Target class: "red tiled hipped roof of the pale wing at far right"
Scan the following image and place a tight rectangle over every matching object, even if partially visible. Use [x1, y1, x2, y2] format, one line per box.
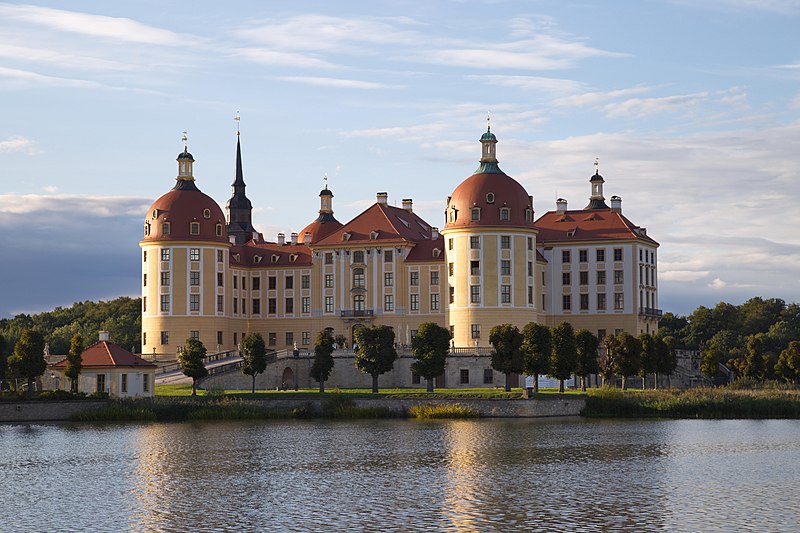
[535, 208, 658, 246]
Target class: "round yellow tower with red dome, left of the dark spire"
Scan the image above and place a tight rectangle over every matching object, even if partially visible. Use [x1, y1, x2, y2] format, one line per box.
[139, 136, 233, 357]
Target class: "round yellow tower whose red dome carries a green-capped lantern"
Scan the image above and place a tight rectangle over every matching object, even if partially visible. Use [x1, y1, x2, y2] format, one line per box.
[442, 127, 539, 347]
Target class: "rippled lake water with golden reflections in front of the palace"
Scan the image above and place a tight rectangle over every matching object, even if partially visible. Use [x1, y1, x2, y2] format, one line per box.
[0, 418, 800, 533]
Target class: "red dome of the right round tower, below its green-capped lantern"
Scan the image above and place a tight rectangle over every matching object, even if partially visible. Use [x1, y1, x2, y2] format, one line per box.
[445, 170, 533, 229]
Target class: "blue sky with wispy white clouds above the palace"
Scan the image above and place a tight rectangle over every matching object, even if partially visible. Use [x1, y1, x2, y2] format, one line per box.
[0, 0, 800, 318]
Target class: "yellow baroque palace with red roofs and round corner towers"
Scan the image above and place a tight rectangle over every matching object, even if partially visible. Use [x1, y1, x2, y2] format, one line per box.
[139, 128, 661, 385]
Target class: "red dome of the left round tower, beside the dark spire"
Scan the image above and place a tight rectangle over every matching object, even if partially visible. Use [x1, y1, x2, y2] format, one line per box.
[142, 181, 228, 243]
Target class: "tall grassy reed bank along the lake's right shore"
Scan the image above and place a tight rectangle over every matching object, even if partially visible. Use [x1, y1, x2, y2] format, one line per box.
[582, 388, 800, 419]
